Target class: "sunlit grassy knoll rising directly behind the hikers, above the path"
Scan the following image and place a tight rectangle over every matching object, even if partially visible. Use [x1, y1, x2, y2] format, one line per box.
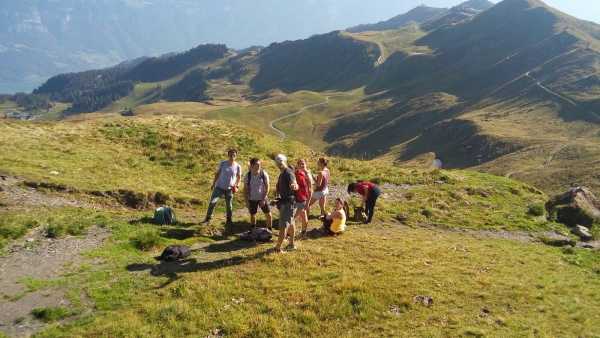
[0, 113, 560, 230]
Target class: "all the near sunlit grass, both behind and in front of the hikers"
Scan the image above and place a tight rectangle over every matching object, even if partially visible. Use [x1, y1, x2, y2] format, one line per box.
[0, 114, 600, 337]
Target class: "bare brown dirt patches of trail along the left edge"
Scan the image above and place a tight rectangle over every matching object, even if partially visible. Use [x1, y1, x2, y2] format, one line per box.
[0, 175, 109, 337]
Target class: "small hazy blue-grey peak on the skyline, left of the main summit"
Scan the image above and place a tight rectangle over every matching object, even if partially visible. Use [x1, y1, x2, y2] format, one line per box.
[346, 5, 448, 33]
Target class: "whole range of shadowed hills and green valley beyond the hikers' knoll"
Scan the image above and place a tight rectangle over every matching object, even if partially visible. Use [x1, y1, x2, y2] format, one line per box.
[7, 0, 600, 199]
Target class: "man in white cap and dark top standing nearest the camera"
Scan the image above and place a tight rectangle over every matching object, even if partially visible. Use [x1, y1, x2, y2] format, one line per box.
[275, 154, 298, 253]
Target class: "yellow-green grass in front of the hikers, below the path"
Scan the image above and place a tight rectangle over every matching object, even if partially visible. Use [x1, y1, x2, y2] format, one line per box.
[31, 213, 600, 337]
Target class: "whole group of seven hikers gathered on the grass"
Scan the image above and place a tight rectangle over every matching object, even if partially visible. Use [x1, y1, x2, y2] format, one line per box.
[204, 149, 381, 252]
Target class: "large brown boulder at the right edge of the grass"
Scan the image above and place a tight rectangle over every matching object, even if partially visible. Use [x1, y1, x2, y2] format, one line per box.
[546, 187, 600, 228]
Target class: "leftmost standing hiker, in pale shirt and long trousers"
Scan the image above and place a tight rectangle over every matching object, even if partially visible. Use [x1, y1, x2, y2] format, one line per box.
[204, 149, 242, 226]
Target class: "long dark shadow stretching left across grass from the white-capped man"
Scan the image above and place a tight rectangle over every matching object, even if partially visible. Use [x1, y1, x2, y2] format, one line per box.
[127, 250, 272, 289]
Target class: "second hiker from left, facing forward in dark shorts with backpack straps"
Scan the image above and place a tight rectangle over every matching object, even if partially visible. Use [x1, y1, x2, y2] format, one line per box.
[244, 158, 273, 229]
